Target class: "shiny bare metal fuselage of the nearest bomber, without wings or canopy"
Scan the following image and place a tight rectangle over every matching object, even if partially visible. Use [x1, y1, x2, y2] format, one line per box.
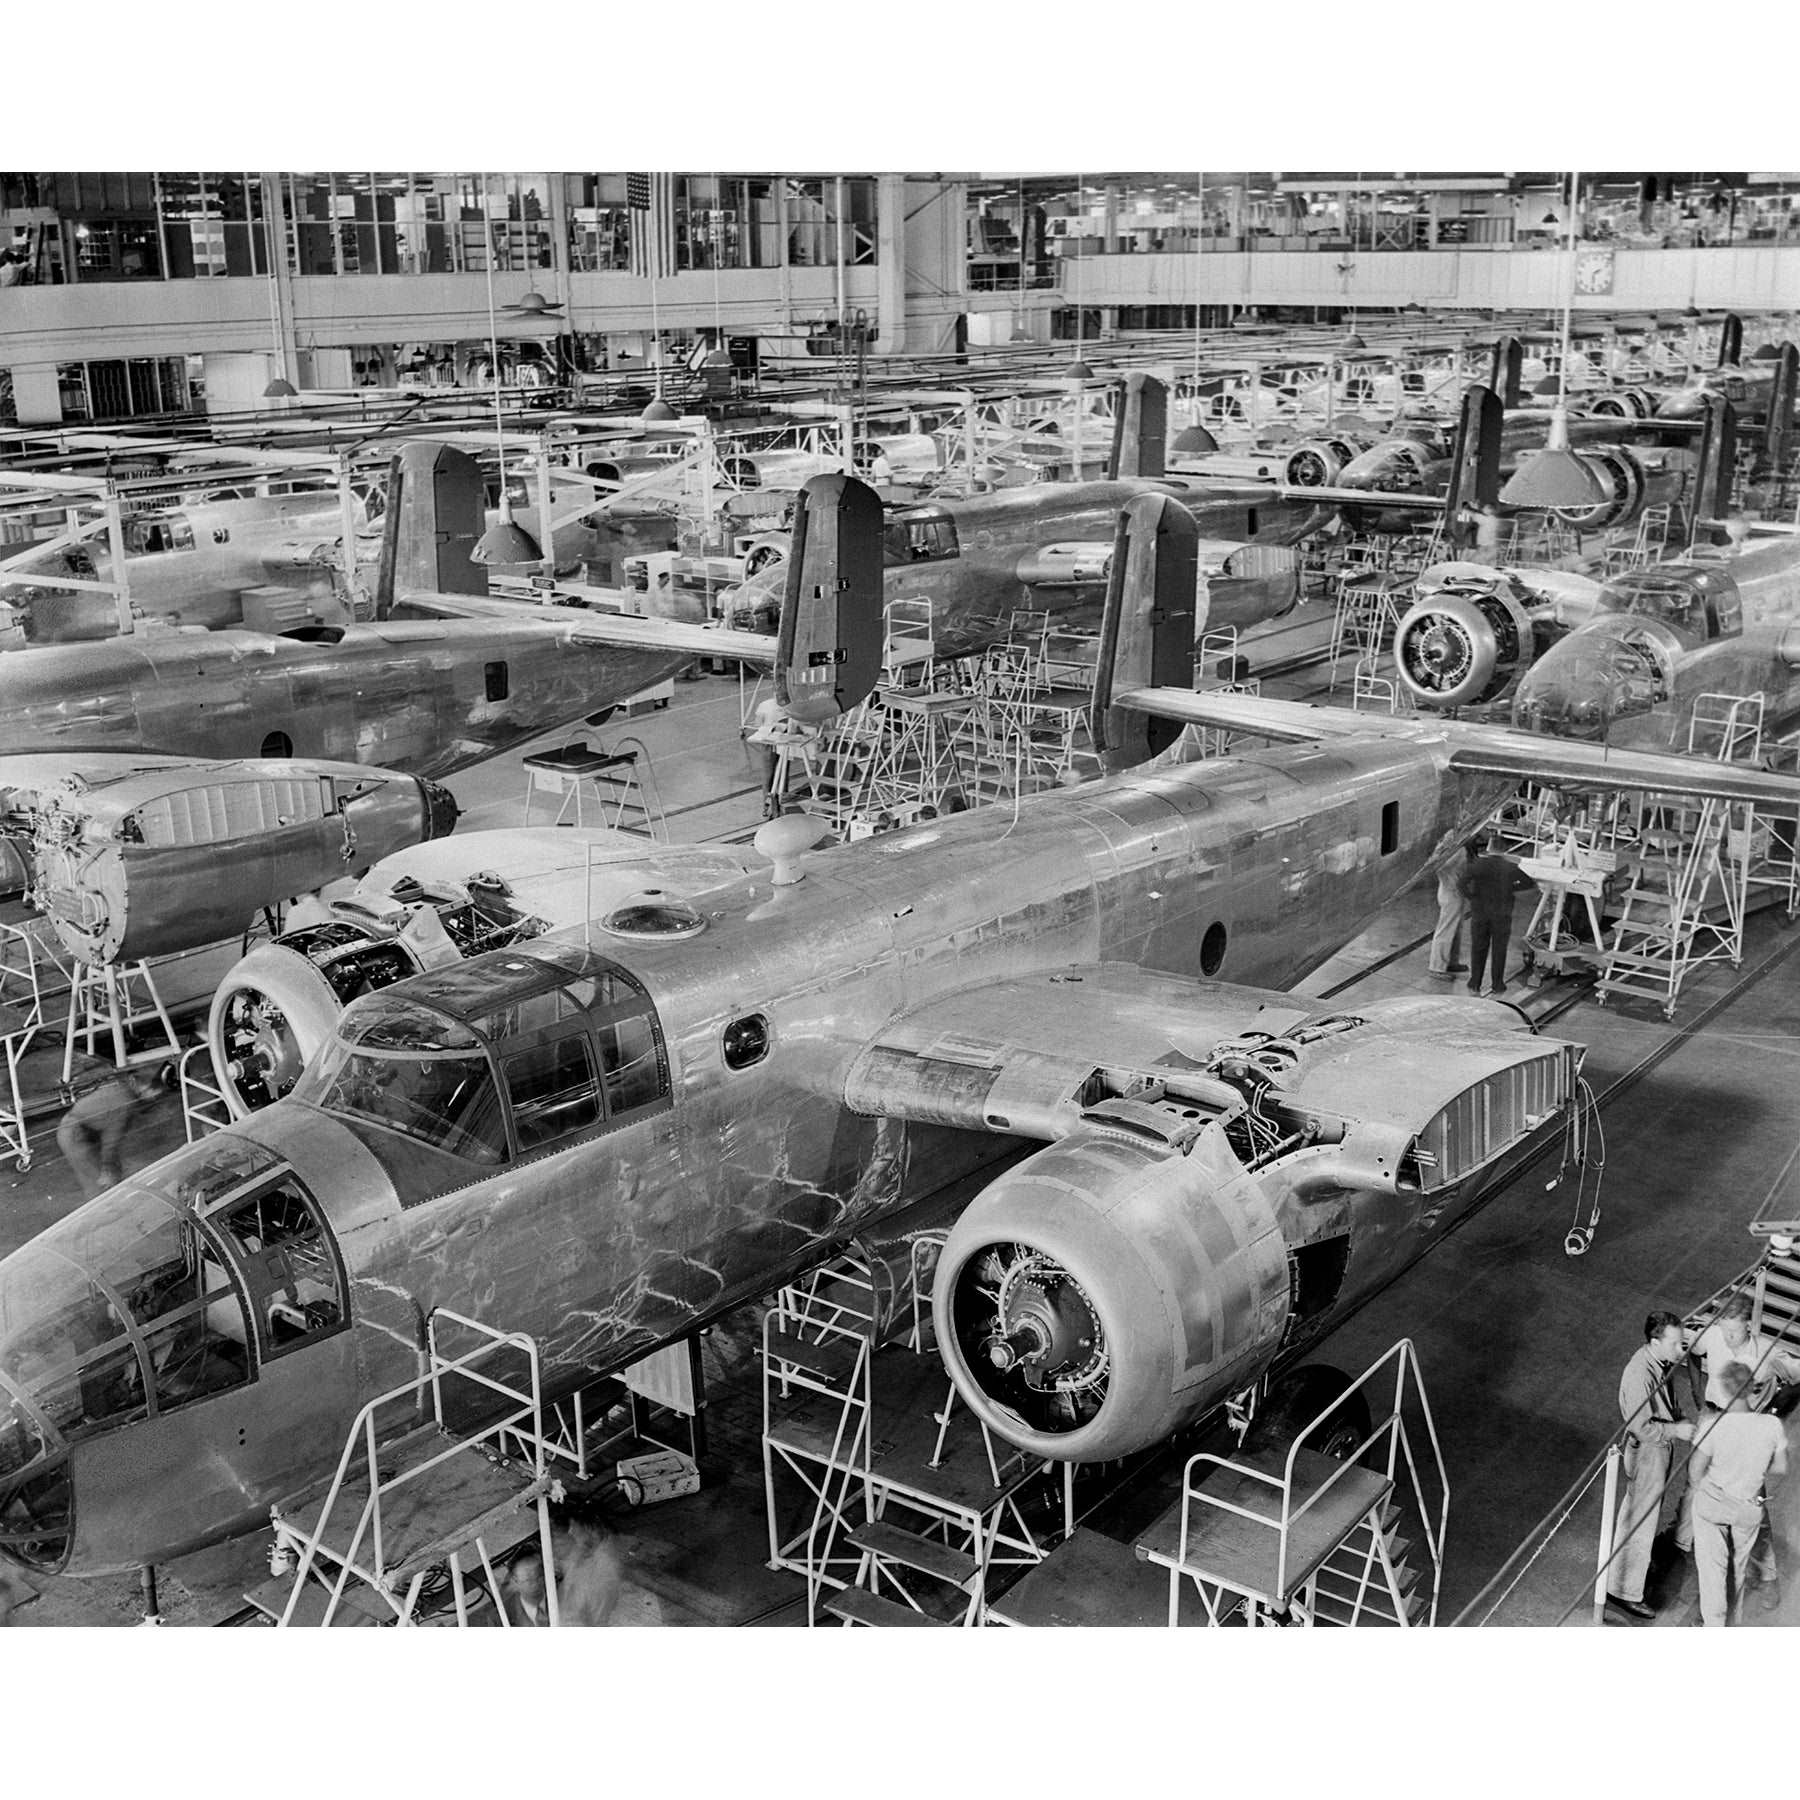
[0, 742, 1505, 1573]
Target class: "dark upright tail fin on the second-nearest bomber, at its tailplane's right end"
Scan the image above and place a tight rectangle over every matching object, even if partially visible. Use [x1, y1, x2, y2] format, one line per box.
[776, 475, 886, 725]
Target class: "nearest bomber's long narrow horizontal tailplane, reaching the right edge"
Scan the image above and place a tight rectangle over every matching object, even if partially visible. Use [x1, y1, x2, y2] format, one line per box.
[1112, 688, 1800, 812]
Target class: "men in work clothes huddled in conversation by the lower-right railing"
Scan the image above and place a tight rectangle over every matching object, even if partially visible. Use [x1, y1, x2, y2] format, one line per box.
[1606, 1292, 1800, 1625]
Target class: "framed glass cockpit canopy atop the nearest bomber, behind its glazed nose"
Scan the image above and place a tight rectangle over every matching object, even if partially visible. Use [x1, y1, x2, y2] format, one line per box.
[293, 941, 670, 1180]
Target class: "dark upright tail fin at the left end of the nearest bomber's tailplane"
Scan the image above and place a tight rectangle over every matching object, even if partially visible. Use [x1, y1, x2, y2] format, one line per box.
[1093, 493, 1201, 769]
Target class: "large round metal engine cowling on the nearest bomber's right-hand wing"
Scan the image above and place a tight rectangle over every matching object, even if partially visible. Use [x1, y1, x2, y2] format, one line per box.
[932, 1103, 1289, 1462]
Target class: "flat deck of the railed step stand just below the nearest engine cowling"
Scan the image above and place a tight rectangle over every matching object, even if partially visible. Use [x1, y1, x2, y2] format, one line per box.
[1138, 1444, 1393, 1607]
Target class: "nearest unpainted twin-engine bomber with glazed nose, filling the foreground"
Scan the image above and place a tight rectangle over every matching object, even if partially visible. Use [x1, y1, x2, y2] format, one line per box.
[0, 477, 1800, 1573]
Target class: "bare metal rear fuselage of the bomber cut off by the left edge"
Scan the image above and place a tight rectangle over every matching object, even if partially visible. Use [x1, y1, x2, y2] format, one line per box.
[0, 619, 691, 778]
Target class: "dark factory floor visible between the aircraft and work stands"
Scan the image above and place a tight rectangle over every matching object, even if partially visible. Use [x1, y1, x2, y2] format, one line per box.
[0, 614, 1800, 1629]
